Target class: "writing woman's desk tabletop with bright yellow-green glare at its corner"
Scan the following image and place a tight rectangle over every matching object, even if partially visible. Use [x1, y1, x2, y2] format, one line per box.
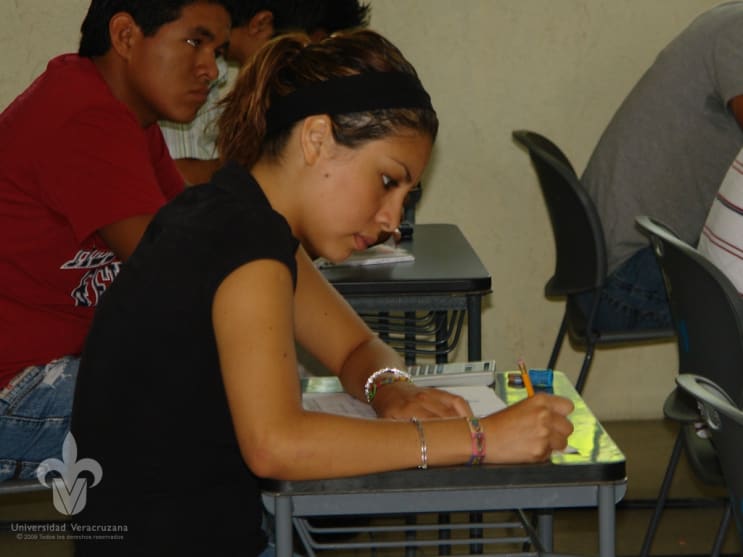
[262, 371, 626, 495]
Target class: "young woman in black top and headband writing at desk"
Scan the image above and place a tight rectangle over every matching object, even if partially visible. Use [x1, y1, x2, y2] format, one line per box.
[72, 30, 572, 555]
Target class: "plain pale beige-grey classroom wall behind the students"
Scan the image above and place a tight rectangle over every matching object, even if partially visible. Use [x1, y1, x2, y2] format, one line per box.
[0, 0, 721, 419]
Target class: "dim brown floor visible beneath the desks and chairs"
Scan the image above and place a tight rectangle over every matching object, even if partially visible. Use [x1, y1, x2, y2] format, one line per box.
[0, 420, 741, 557]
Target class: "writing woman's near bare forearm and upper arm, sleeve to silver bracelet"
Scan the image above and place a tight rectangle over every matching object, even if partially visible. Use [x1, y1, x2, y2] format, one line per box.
[212, 260, 442, 478]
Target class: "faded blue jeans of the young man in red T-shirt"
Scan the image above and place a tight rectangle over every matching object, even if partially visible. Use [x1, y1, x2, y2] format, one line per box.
[0, 356, 80, 481]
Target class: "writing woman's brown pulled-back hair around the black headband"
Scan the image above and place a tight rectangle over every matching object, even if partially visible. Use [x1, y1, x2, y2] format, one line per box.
[217, 29, 438, 169]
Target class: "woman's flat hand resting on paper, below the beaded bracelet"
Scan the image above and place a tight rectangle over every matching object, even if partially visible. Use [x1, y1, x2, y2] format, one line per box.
[372, 381, 472, 420]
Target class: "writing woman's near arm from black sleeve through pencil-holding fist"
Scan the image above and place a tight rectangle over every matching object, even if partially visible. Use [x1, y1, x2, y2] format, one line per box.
[212, 254, 572, 479]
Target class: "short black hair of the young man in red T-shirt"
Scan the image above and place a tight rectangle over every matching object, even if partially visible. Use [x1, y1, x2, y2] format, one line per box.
[77, 0, 232, 58]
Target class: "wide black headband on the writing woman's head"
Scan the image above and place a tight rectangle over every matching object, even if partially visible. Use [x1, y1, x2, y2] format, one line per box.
[266, 72, 433, 134]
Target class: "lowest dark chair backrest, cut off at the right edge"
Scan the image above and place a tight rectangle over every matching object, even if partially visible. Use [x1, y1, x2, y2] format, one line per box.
[676, 373, 743, 542]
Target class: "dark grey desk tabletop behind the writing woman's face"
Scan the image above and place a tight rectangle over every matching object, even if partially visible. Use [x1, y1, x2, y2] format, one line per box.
[322, 224, 491, 296]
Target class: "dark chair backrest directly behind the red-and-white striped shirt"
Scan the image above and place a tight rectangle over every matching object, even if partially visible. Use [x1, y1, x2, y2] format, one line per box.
[637, 216, 743, 404]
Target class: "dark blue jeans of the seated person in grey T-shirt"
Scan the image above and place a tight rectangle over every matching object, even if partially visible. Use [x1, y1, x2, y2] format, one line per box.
[576, 247, 672, 331]
